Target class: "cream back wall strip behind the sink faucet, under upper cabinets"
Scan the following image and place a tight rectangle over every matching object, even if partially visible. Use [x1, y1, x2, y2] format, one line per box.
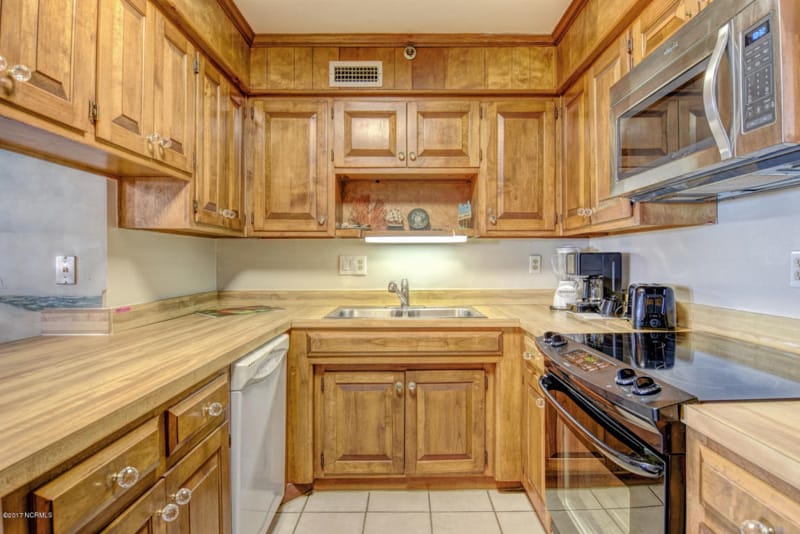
[217, 239, 588, 290]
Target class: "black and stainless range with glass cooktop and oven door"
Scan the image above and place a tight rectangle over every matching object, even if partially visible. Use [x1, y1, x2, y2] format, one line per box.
[536, 332, 800, 534]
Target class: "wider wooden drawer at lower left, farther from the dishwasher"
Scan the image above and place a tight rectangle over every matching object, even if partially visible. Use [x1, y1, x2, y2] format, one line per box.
[33, 418, 163, 534]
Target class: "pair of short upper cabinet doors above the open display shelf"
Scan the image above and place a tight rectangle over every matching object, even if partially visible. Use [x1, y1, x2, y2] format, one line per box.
[333, 100, 480, 168]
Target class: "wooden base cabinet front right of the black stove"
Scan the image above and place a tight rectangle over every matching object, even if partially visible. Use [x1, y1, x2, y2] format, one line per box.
[686, 429, 800, 534]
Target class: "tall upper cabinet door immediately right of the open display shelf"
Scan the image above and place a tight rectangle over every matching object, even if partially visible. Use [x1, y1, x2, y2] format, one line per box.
[486, 99, 556, 235]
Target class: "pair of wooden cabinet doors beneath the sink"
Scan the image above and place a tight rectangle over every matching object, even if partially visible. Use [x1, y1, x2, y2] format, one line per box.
[316, 369, 488, 476]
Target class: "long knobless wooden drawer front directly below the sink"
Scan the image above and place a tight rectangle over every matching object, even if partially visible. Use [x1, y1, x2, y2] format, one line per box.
[307, 330, 503, 356]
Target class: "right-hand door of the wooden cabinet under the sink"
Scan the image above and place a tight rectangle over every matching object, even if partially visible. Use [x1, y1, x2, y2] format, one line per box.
[406, 370, 486, 475]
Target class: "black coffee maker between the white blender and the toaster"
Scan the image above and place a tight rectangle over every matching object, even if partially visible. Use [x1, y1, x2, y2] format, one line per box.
[567, 252, 624, 315]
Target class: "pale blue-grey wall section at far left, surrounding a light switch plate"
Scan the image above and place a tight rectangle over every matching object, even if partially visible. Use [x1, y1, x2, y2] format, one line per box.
[0, 150, 106, 341]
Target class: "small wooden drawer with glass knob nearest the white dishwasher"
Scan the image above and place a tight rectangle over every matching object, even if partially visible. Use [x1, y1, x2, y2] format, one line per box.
[167, 375, 229, 456]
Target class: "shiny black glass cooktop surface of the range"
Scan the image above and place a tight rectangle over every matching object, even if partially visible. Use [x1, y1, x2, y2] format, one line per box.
[565, 332, 800, 402]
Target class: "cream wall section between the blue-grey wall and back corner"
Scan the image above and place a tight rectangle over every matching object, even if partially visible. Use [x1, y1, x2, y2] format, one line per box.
[107, 182, 217, 306]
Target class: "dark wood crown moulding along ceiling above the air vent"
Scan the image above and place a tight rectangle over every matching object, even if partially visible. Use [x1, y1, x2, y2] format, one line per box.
[252, 33, 556, 48]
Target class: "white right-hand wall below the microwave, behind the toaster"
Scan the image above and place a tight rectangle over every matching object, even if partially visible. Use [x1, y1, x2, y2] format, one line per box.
[590, 189, 800, 318]
